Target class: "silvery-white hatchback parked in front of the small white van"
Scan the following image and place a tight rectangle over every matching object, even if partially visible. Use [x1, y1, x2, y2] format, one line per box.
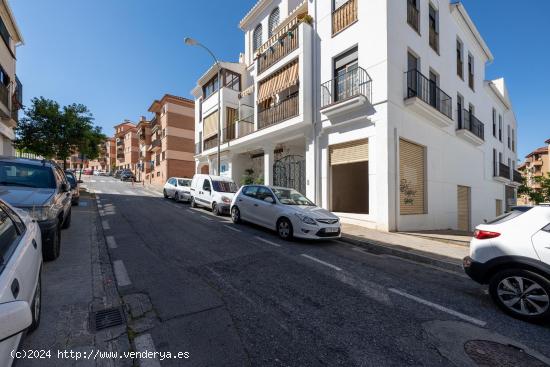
[231, 185, 341, 240]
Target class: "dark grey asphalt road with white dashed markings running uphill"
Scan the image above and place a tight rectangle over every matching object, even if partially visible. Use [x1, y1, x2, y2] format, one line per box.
[85, 176, 550, 366]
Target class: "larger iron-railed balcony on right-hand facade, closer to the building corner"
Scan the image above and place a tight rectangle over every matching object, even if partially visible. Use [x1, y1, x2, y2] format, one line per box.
[405, 70, 453, 127]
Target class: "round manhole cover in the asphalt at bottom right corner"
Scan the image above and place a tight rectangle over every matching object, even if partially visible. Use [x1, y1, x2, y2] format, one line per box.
[464, 340, 548, 367]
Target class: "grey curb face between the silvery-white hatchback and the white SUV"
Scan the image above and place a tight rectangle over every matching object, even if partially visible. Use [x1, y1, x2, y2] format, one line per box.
[340, 233, 463, 272]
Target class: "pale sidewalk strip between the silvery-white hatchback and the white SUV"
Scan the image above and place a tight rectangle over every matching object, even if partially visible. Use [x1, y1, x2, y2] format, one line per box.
[342, 223, 469, 270]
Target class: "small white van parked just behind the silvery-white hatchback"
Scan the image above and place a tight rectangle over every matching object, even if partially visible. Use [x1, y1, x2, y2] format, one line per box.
[191, 174, 238, 215]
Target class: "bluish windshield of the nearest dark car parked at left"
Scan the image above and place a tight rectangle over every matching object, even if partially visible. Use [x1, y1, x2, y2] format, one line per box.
[0, 162, 56, 189]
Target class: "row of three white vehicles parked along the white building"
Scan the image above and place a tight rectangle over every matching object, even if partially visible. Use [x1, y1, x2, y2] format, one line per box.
[163, 174, 341, 240]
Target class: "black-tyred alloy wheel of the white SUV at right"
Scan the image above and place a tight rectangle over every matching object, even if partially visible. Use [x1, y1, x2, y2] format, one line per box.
[489, 269, 550, 322]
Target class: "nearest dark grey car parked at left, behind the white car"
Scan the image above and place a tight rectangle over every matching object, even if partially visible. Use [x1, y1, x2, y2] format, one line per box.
[0, 156, 71, 261]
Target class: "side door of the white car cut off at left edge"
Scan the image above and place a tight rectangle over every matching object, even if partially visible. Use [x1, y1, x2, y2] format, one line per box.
[0, 203, 37, 365]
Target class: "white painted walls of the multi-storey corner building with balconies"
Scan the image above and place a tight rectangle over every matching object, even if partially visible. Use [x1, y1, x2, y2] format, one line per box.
[194, 0, 517, 231]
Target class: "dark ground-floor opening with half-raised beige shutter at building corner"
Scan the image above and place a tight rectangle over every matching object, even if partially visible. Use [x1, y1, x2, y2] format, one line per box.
[330, 139, 369, 214]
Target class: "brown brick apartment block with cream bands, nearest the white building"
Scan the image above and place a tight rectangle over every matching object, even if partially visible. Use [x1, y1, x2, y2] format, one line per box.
[147, 94, 195, 186]
